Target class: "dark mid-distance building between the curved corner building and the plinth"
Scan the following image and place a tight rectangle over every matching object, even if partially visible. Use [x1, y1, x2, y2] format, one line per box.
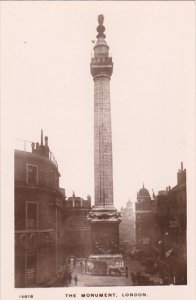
[61, 192, 91, 260]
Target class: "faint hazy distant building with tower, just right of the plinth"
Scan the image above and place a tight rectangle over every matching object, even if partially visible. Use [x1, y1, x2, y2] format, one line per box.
[119, 200, 135, 253]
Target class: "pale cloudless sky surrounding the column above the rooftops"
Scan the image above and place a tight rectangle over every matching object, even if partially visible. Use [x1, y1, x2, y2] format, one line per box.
[1, 1, 195, 208]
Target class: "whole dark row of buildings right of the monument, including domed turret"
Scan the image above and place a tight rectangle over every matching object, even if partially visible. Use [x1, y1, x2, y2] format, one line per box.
[136, 163, 187, 285]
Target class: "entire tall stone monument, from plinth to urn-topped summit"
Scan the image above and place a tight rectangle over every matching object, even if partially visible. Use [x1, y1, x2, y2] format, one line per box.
[88, 15, 123, 275]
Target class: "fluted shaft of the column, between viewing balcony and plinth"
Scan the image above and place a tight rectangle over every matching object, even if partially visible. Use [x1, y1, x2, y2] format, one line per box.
[94, 75, 113, 207]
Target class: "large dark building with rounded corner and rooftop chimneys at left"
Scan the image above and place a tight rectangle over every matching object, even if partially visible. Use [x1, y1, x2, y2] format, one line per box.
[14, 133, 64, 287]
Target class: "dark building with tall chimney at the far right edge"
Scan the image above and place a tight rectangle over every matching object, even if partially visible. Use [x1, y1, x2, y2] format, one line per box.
[156, 163, 187, 284]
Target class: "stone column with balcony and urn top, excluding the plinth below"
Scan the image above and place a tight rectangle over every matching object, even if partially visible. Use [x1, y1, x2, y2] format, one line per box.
[91, 15, 114, 210]
